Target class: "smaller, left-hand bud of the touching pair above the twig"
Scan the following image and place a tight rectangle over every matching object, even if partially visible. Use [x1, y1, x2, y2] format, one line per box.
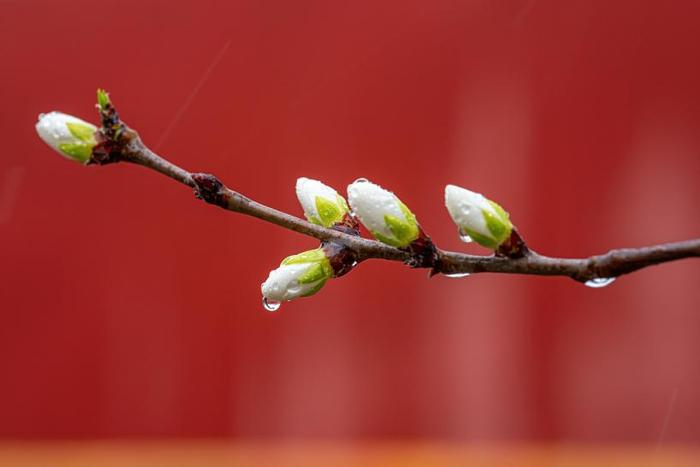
[296, 177, 349, 227]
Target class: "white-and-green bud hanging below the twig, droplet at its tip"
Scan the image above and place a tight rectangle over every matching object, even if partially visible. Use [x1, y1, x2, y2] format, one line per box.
[260, 248, 333, 302]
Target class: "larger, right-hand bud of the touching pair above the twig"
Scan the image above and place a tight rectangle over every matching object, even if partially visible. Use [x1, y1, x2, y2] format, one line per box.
[348, 179, 420, 248]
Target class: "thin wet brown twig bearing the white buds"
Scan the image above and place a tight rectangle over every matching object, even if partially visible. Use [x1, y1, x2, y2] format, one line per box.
[89, 109, 700, 282]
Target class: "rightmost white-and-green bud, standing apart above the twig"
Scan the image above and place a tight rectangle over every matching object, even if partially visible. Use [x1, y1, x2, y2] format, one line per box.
[445, 185, 513, 250]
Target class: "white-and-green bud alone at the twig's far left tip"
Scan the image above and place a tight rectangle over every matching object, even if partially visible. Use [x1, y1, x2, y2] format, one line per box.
[36, 112, 97, 164]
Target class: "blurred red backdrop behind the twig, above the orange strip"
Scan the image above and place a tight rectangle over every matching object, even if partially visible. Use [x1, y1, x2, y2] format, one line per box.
[0, 0, 700, 443]
